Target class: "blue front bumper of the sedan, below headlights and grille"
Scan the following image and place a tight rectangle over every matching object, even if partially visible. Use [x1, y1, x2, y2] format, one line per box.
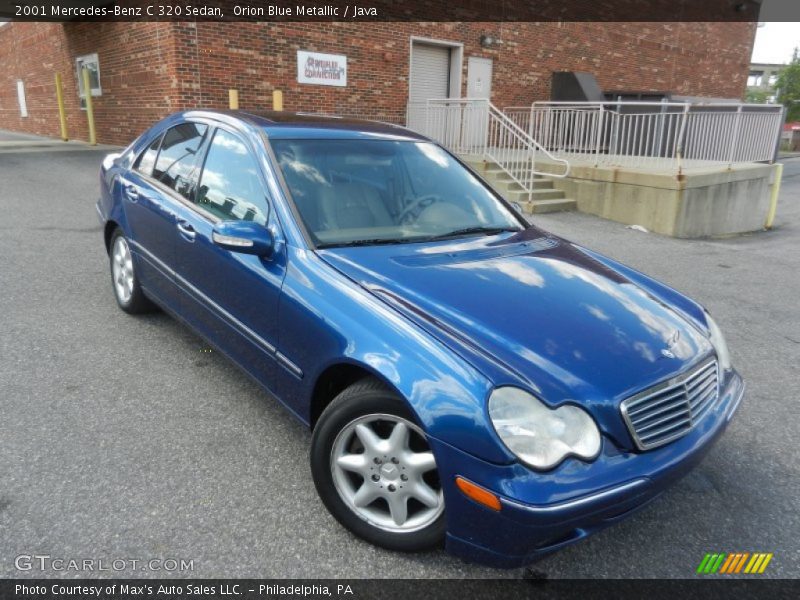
[430, 371, 744, 568]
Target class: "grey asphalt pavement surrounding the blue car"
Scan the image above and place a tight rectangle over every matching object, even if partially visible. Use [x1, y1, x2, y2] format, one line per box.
[0, 136, 800, 578]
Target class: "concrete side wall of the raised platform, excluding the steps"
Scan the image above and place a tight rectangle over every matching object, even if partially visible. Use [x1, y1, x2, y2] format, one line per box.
[554, 164, 775, 238]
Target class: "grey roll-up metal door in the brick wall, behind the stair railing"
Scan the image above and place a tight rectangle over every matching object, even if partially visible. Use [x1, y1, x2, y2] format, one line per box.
[408, 42, 450, 129]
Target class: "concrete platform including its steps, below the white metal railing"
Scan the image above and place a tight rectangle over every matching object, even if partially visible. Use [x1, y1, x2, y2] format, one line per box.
[464, 155, 776, 238]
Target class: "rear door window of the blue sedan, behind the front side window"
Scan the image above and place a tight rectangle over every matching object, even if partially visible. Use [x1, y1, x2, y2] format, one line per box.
[153, 123, 208, 200]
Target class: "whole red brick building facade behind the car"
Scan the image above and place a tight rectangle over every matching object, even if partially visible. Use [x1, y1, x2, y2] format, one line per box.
[0, 22, 755, 144]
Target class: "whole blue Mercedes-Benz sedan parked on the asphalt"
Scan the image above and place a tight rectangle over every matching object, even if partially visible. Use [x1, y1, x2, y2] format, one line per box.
[97, 111, 744, 567]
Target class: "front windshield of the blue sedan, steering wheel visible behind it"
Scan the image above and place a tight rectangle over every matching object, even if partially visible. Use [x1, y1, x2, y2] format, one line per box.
[271, 139, 523, 247]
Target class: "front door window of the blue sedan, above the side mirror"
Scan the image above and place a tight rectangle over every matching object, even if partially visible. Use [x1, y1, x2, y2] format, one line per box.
[197, 129, 269, 225]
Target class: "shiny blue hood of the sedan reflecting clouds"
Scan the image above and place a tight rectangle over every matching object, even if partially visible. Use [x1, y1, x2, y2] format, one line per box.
[320, 228, 712, 446]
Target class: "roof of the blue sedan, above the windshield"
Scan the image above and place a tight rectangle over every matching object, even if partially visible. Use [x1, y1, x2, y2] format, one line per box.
[184, 110, 429, 141]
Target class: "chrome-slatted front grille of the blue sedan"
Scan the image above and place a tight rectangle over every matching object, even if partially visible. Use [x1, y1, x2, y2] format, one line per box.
[620, 360, 719, 450]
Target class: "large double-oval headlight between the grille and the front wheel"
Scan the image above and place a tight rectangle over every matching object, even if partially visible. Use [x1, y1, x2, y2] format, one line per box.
[489, 387, 600, 469]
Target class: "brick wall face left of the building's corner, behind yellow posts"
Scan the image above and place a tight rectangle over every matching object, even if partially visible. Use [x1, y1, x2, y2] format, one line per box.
[0, 23, 180, 144]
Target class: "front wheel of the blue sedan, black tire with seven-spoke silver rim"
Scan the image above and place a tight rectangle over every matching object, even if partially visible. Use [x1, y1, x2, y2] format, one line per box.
[311, 378, 445, 552]
